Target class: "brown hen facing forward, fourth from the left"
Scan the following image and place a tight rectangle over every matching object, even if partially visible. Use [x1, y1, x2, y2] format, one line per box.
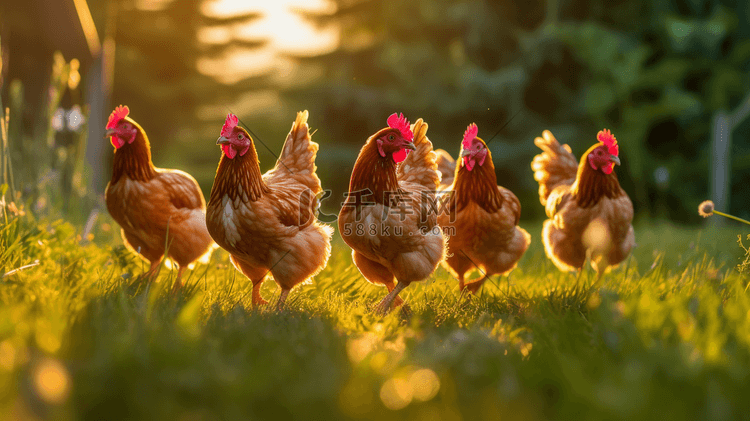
[438, 124, 531, 293]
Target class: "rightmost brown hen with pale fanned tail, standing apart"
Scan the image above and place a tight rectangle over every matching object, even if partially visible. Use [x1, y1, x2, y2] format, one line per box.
[531, 129, 635, 280]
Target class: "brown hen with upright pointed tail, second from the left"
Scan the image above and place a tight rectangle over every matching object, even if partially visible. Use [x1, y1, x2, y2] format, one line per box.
[206, 111, 333, 309]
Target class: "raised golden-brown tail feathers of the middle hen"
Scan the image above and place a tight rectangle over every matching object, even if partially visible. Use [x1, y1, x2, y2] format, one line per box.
[396, 118, 440, 191]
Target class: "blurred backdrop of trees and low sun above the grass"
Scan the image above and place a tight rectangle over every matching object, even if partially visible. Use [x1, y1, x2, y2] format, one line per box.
[0, 0, 750, 223]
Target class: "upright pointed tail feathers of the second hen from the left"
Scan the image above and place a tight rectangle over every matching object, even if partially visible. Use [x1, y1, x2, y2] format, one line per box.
[264, 111, 322, 194]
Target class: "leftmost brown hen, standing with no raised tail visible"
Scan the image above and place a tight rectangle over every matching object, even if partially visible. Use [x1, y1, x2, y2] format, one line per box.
[104, 105, 213, 290]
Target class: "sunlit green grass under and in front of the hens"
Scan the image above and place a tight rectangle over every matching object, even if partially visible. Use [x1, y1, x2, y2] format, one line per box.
[0, 208, 750, 420]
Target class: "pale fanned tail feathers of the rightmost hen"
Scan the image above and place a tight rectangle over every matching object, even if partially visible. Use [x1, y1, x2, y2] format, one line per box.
[531, 130, 578, 205]
